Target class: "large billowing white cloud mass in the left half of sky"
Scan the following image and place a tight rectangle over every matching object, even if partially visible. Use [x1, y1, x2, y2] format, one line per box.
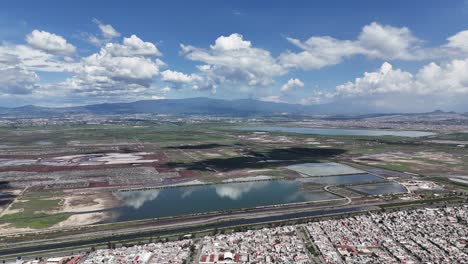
[62, 35, 165, 95]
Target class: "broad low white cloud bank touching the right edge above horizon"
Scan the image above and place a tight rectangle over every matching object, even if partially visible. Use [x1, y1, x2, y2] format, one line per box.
[308, 59, 468, 112]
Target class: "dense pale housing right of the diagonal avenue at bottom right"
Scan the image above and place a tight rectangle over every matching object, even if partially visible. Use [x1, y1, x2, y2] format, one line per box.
[306, 206, 468, 263]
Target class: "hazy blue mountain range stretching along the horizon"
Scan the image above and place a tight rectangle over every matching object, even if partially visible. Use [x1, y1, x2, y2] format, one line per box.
[0, 97, 462, 116]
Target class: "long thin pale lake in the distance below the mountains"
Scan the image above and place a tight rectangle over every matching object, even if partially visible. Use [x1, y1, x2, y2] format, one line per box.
[240, 126, 435, 137]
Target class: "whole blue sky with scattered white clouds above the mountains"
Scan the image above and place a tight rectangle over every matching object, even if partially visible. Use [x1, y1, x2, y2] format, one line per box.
[0, 0, 468, 112]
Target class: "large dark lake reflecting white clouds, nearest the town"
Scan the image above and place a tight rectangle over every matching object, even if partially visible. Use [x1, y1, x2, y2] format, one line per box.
[111, 180, 340, 222]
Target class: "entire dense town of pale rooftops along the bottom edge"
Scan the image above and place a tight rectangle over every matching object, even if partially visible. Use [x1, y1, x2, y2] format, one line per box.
[12, 205, 468, 264]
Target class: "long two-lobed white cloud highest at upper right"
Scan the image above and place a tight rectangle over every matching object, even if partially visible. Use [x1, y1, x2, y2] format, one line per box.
[279, 22, 426, 70]
